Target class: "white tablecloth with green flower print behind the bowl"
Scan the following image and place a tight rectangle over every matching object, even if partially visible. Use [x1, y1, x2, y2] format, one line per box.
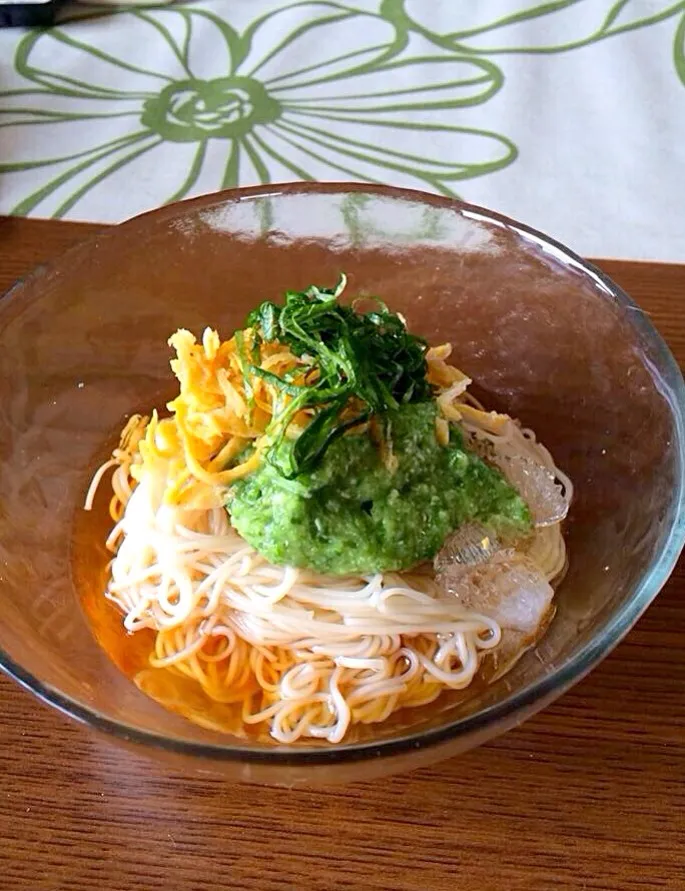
[0, 0, 685, 261]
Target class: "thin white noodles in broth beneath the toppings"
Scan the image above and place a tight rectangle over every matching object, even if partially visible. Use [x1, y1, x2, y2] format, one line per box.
[87, 374, 572, 743]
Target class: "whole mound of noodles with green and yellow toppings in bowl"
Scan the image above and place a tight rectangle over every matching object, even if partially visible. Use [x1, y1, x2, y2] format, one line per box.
[86, 277, 573, 743]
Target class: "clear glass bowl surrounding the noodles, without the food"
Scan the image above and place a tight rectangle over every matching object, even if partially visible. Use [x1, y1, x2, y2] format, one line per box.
[0, 184, 684, 785]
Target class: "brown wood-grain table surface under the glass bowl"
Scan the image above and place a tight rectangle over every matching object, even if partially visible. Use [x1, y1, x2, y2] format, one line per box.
[0, 220, 685, 891]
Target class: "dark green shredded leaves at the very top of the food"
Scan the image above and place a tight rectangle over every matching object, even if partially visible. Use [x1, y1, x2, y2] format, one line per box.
[242, 275, 433, 479]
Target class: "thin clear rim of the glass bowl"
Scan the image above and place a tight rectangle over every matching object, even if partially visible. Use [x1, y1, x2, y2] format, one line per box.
[0, 182, 685, 767]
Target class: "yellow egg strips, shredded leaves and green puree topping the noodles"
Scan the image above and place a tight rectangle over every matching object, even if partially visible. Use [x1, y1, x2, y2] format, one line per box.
[128, 279, 532, 575]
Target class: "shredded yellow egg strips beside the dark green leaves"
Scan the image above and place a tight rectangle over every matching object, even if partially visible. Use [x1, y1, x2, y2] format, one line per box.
[131, 328, 499, 509]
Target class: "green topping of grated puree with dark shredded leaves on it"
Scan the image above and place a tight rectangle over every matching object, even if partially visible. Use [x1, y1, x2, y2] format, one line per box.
[227, 276, 532, 575]
